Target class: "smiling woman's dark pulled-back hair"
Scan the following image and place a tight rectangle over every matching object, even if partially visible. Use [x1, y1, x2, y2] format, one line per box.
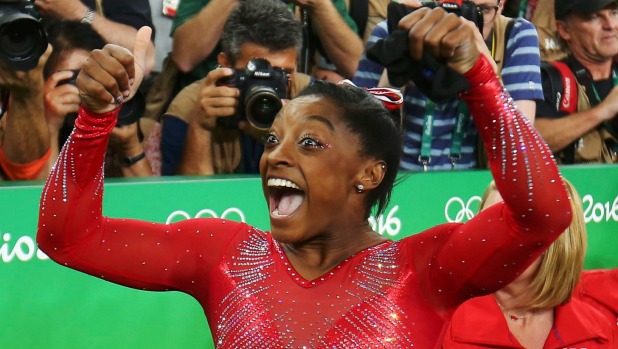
[297, 81, 402, 216]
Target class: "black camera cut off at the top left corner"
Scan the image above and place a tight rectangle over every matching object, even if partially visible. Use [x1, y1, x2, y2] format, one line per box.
[0, 0, 47, 71]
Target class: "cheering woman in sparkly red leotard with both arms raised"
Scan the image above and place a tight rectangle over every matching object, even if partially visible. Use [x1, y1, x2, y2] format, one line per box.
[37, 5, 571, 348]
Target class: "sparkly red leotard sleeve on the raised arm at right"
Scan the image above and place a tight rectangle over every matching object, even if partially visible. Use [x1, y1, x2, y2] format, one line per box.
[408, 58, 571, 309]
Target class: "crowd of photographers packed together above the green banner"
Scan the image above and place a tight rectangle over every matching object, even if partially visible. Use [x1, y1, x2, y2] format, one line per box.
[0, 0, 618, 180]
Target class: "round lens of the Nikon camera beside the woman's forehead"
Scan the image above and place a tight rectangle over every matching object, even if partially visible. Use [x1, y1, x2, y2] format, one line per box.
[245, 86, 283, 129]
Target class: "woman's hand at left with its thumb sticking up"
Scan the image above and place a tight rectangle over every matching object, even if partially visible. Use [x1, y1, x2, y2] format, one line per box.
[77, 27, 152, 114]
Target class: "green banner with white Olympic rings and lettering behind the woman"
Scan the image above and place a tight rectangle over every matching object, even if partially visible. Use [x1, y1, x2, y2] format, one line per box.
[0, 166, 618, 349]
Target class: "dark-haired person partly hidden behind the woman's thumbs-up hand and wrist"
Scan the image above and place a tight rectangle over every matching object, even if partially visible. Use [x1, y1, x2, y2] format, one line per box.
[45, 21, 157, 177]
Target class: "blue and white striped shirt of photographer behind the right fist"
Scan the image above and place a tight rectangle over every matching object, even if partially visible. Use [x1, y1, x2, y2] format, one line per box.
[353, 18, 543, 170]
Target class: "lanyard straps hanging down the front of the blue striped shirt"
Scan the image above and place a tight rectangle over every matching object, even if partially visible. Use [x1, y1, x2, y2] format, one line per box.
[418, 99, 470, 171]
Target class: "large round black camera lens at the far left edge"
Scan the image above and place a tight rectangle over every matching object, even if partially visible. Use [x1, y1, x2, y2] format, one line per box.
[0, 14, 47, 70]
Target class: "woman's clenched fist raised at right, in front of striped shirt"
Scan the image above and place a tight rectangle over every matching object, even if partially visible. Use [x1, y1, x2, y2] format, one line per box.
[399, 7, 479, 74]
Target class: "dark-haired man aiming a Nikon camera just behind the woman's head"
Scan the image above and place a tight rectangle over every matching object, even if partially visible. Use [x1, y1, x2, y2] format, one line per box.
[161, 0, 308, 175]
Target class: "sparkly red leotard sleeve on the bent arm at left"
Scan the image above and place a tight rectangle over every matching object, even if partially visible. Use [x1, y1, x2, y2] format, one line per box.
[37, 109, 245, 294]
